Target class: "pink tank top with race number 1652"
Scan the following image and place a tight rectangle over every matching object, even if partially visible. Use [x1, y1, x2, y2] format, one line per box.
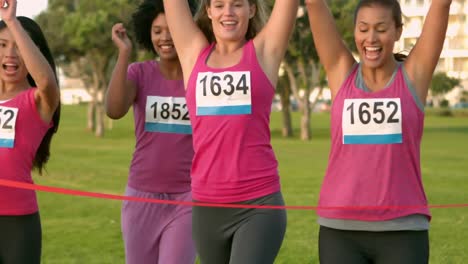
[318, 66, 430, 221]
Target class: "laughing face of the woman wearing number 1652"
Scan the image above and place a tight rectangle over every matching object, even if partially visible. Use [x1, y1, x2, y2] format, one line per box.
[354, 5, 402, 68]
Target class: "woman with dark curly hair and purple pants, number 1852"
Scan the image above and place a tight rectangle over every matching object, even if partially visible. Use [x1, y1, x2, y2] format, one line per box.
[106, 0, 196, 264]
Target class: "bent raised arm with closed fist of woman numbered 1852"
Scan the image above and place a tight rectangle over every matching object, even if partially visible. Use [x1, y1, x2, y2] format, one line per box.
[105, 23, 136, 119]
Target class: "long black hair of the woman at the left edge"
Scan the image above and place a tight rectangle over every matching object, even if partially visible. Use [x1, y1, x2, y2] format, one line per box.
[0, 16, 60, 174]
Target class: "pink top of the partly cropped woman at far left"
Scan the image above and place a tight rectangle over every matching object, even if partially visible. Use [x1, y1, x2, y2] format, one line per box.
[0, 88, 52, 215]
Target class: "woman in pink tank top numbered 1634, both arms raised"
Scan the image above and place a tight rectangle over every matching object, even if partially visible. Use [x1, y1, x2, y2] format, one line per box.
[164, 0, 299, 264]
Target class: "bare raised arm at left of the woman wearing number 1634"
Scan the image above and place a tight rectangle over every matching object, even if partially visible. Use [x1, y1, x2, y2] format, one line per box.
[164, 0, 208, 83]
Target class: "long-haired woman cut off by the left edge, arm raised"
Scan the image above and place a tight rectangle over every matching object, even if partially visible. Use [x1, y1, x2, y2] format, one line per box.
[0, 0, 60, 264]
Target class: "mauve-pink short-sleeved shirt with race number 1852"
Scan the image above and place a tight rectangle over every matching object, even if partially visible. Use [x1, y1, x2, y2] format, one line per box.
[127, 60, 193, 193]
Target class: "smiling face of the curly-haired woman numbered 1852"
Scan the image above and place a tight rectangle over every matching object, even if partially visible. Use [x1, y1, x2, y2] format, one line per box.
[151, 14, 178, 60]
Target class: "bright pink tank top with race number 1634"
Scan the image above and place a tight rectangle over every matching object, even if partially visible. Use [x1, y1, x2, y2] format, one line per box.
[186, 41, 280, 203]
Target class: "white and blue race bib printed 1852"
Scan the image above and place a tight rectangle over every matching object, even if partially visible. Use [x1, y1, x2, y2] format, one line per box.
[145, 96, 192, 134]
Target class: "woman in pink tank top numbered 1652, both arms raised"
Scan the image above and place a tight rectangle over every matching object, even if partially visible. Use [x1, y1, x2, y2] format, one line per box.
[306, 0, 451, 264]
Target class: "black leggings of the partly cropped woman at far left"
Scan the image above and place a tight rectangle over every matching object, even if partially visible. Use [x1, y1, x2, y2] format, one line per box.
[0, 213, 42, 264]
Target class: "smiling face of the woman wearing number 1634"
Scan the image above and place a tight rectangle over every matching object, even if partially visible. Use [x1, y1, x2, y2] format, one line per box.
[207, 0, 256, 41]
